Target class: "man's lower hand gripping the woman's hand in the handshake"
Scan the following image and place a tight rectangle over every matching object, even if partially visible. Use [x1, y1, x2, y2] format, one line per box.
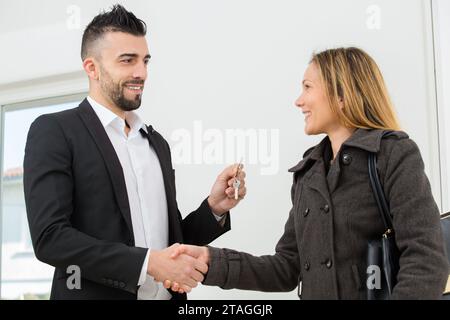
[147, 243, 208, 292]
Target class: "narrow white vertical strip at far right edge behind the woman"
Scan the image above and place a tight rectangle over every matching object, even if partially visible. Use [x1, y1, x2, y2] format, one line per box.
[432, 0, 450, 212]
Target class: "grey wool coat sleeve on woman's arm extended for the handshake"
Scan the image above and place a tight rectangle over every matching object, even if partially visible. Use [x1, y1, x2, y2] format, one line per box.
[203, 181, 300, 292]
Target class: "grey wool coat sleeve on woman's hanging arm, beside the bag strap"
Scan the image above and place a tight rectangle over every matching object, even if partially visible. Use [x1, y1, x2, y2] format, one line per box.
[384, 139, 449, 299]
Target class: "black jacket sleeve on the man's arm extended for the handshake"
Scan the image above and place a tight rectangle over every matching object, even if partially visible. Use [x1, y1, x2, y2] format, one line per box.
[24, 115, 147, 294]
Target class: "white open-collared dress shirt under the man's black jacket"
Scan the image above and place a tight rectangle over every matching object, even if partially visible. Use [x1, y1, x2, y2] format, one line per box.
[87, 97, 226, 300]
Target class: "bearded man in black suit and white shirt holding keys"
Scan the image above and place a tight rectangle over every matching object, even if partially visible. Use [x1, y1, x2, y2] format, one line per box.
[24, 5, 246, 299]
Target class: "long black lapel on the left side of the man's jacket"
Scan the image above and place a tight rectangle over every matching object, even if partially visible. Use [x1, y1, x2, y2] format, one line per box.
[79, 99, 134, 239]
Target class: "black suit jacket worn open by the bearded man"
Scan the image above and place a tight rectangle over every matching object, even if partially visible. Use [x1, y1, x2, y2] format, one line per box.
[24, 99, 230, 299]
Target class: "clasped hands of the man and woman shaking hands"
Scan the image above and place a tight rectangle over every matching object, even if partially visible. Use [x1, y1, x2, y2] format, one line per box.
[147, 243, 209, 293]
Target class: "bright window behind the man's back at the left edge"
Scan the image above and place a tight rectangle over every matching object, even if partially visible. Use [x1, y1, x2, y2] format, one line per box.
[0, 95, 82, 299]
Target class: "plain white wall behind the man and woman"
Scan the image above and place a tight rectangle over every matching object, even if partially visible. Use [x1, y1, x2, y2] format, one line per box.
[0, 0, 440, 299]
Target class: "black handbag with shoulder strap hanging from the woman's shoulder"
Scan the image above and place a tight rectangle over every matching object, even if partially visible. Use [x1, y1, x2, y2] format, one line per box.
[366, 153, 400, 300]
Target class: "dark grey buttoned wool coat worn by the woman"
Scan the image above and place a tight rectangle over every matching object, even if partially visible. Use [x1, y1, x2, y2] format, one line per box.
[203, 129, 449, 299]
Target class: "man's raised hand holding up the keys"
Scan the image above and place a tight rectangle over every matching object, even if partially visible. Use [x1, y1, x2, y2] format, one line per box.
[208, 164, 247, 215]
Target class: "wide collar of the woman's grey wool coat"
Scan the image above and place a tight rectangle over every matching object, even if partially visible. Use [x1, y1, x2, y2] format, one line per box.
[288, 128, 408, 172]
